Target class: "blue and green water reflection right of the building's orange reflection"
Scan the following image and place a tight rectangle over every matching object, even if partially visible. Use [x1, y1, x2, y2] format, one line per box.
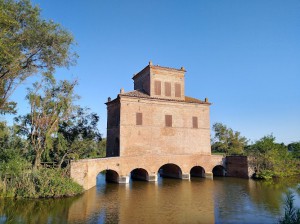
[214, 177, 300, 224]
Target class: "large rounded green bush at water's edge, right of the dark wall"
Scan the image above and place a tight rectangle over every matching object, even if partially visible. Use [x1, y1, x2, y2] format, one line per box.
[246, 135, 299, 179]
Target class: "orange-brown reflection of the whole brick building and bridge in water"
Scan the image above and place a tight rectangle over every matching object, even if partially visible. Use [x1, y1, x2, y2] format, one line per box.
[67, 180, 215, 224]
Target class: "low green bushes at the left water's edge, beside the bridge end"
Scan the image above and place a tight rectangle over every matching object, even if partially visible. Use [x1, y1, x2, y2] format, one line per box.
[0, 168, 83, 198]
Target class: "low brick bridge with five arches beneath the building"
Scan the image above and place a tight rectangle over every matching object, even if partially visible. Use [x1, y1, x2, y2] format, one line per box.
[70, 154, 225, 190]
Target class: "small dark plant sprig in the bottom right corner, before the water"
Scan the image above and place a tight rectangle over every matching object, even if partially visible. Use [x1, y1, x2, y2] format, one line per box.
[278, 191, 300, 224]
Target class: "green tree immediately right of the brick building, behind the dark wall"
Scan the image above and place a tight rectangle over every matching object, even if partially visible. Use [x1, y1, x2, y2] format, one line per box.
[212, 123, 248, 155]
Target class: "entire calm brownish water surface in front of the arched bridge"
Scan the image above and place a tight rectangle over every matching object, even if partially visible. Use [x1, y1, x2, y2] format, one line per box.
[0, 175, 300, 224]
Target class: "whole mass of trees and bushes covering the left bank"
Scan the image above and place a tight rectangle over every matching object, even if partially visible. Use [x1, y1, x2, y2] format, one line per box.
[0, 0, 91, 198]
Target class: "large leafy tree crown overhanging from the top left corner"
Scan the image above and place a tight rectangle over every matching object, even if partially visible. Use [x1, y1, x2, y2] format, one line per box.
[0, 0, 77, 114]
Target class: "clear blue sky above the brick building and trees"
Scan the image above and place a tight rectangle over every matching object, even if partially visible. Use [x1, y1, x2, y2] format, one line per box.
[4, 0, 300, 144]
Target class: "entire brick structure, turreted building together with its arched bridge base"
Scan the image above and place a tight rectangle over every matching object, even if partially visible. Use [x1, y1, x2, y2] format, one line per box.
[70, 63, 248, 189]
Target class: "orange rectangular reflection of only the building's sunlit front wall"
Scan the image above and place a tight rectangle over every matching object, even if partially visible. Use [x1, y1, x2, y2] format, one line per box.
[120, 179, 214, 223]
